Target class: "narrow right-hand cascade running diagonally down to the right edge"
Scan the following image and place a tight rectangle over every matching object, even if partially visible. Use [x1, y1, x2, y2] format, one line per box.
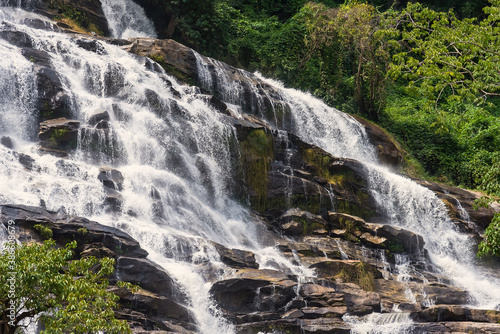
[193, 56, 500, 309]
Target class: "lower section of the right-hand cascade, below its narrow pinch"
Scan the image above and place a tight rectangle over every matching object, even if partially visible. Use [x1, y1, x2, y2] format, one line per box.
[369, 166, 500, 309]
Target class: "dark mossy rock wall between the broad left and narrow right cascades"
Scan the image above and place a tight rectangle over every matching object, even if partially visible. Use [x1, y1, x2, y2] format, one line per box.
[236, 124, 377, 220]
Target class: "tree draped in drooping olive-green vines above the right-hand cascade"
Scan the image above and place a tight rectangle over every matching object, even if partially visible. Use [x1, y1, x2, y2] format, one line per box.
[304, 1, 389, 120]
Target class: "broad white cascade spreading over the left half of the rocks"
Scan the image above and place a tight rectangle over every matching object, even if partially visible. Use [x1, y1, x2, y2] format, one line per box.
[0, 1, 312, 333]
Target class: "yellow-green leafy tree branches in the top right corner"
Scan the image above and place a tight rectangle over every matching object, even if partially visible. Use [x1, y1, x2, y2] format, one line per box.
[384, 0, 500, 109]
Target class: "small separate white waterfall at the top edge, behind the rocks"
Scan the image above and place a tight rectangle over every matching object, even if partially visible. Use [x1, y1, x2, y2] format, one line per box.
[100, 0, 157, 39]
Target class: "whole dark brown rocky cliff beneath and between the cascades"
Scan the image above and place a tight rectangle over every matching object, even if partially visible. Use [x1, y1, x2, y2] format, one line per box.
[0, 1, 500, 333]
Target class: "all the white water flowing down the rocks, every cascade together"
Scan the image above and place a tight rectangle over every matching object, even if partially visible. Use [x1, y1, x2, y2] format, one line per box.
[0, 0, 500, 334]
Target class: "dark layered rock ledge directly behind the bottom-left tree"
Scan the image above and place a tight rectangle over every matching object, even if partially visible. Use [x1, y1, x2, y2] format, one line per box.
[0, 205, 196, 333]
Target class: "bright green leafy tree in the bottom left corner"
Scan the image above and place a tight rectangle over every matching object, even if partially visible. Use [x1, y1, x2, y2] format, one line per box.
[0, 240, 131, 334]
